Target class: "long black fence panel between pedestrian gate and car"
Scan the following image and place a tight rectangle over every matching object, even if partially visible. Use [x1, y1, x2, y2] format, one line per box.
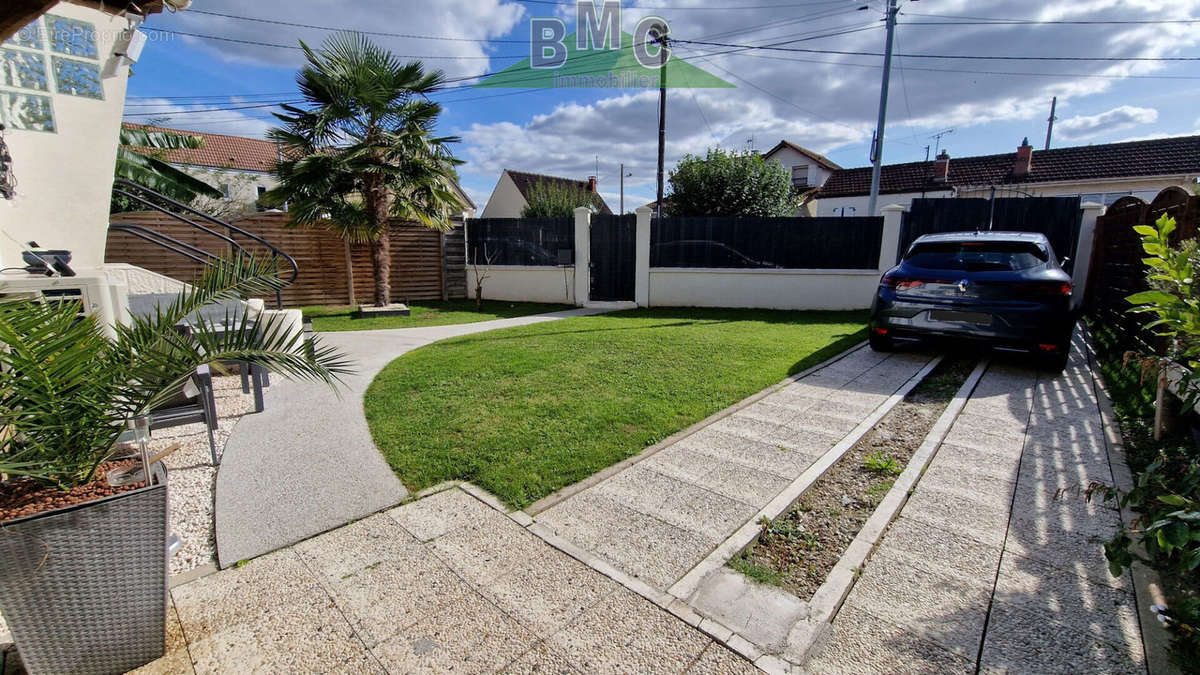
[650, 216, 883, 269]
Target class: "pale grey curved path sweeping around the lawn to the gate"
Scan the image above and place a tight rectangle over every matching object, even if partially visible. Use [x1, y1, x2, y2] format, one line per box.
[215, 309, 607, 567]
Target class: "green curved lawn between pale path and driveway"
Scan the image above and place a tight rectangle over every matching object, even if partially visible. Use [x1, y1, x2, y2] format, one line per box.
[365, 309, 866, 507]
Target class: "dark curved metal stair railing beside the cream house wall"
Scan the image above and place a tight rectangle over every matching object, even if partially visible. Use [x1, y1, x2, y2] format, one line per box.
[108, 178, 300, 309]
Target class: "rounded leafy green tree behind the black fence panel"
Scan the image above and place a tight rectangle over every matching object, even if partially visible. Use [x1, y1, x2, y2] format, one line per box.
[665, 148, 799, 217]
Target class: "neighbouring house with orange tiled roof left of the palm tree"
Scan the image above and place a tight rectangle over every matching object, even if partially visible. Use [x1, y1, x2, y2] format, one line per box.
[124, 123, 280, 217]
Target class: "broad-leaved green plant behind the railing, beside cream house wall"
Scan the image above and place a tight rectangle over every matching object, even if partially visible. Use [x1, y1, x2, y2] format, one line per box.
[110, 127, 224, 214]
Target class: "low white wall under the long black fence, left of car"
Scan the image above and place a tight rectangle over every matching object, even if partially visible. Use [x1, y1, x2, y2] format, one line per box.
[649, 268, 880, 310]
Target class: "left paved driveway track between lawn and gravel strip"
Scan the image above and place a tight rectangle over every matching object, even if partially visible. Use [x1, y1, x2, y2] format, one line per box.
[535, 348, 932, 591]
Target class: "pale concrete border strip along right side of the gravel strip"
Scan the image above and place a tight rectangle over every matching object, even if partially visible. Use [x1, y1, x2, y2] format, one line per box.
[786, 359, 990, 665]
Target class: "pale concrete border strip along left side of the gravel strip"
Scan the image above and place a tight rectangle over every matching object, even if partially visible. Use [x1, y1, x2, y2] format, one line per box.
[667, 356, 944, 601]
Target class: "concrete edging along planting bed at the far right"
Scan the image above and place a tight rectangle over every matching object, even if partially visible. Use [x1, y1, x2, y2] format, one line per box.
[1084, 330, 1180, 675]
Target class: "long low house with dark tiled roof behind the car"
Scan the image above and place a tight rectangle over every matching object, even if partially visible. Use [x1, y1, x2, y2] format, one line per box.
[816, 136, 1200, 216]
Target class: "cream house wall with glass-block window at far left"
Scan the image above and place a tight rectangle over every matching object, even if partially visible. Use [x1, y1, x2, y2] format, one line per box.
[0, 0, 171, 268]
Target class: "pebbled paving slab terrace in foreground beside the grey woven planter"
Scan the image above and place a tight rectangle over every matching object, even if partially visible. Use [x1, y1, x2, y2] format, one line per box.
[152, 488, 752, 674]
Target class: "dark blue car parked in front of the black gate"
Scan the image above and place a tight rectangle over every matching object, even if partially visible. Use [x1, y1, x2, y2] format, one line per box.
[870, 232, 1075, 372]
